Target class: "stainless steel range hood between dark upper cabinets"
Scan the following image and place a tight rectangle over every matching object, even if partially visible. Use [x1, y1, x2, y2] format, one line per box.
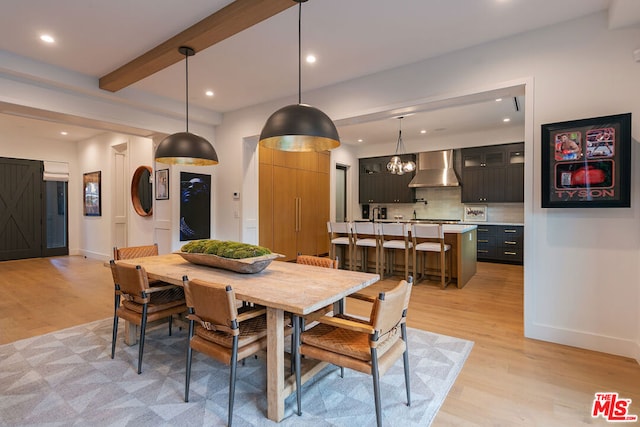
[409, 150, 460, 188]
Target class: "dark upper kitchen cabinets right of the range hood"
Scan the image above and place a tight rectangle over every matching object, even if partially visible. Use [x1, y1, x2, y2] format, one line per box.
[462, 143, 524, 203]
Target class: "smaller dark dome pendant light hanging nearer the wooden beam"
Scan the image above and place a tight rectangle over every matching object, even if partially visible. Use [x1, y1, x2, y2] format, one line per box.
[155, 46, 218, 166]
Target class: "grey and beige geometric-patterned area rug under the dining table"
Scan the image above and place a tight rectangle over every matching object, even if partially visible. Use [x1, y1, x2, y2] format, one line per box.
[0, 319, 473, 427]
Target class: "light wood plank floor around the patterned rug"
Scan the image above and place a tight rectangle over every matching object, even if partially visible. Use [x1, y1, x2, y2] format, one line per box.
[0, 257, 640, 427]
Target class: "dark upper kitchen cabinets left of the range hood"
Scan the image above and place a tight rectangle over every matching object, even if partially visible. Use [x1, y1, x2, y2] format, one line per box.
[359, 154, 416, 204]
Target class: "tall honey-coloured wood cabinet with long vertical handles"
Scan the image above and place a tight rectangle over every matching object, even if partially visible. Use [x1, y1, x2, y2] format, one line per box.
[259, 147, 331, 261]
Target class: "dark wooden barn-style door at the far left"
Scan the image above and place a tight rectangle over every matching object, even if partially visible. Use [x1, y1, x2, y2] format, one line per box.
[0, 157, 43, 261]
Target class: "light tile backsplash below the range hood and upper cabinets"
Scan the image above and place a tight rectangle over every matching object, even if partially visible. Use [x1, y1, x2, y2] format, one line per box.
[362, 187, 524, 223]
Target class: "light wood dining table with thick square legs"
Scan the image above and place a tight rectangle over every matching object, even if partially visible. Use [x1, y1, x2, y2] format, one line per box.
[117, 254, 380, 422]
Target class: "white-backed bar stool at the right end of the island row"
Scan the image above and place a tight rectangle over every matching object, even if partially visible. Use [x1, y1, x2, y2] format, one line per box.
[411, 224, 452, 289]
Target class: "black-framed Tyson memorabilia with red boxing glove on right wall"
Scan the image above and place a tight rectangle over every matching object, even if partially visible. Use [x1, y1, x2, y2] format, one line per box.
[541, 113, 631, 208]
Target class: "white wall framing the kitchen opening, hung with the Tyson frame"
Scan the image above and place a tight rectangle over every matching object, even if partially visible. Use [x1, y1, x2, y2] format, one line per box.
[216, 14, 640, 360]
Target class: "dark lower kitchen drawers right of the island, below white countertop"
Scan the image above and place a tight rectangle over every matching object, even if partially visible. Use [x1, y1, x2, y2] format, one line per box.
[477, 224, 524, 264]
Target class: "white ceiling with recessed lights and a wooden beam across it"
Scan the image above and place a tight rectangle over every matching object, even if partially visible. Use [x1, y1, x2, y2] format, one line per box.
[0, 0, 638, 142]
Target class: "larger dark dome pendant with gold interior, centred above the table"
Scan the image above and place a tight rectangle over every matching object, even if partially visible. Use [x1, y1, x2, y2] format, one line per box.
[260, 0, 340, 151]
